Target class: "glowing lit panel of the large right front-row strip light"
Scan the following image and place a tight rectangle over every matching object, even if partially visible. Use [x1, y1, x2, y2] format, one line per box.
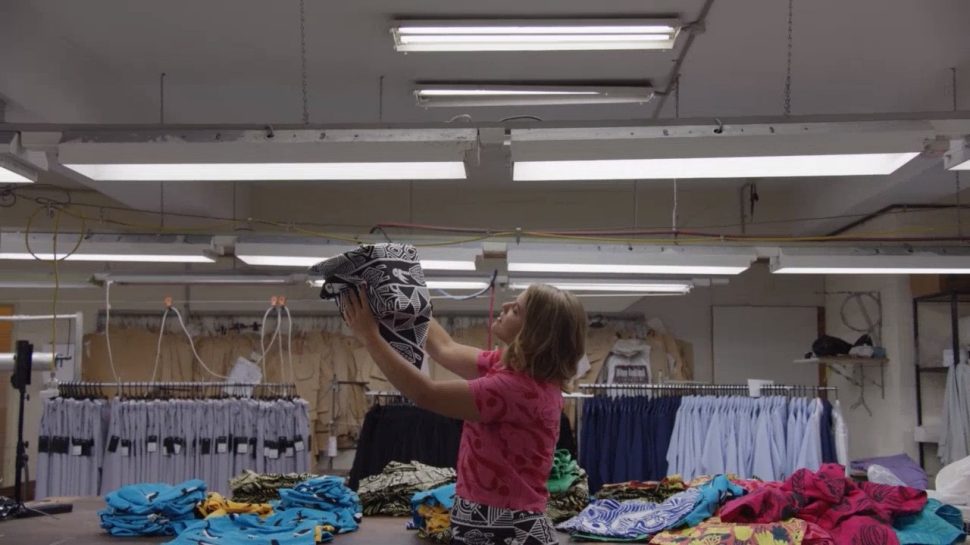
[512, 153, 919, 182]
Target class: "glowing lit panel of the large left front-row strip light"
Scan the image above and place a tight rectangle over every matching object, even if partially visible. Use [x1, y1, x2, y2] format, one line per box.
[64, 161, 465, 181]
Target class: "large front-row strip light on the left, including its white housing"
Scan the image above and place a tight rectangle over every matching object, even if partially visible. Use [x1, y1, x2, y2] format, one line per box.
[58, 129, 477, 181]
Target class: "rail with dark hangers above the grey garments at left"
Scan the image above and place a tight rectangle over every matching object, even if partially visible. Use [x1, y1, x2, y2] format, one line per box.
[58, 382, 297, 399]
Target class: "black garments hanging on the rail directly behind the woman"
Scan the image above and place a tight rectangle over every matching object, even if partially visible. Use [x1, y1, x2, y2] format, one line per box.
[347, 403, 576, 490]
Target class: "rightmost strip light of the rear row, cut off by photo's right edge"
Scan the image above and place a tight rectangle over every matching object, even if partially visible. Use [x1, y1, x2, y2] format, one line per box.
[771, 250, 970, 274]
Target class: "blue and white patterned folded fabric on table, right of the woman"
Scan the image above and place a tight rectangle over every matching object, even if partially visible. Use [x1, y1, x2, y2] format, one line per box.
[557, 488, 702, 541]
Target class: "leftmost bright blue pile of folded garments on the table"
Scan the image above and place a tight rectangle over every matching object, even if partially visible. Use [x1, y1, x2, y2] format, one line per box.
[98, 479, 206, 536]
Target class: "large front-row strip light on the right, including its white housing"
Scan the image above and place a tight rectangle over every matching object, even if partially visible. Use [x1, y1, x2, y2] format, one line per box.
[511, 119, 937, 181]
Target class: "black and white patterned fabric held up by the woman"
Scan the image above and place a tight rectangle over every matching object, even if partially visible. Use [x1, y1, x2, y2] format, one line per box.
[310, 243, 432, 367]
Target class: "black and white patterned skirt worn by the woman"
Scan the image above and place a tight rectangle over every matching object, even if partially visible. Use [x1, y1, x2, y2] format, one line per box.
[451, 497, 559, 545]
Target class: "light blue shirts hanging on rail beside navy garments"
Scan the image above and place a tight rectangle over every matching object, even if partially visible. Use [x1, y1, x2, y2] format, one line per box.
[667, 396, 832, 481]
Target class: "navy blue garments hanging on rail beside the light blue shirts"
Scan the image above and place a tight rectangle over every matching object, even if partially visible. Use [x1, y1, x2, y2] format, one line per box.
[579, 396, 680, 492]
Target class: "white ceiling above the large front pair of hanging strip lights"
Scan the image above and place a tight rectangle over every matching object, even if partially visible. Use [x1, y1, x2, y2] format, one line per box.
[0, 0, 970, 123]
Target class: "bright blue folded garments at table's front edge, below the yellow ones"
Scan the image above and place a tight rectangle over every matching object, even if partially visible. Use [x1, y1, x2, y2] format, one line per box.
[167, 509, 336, 545]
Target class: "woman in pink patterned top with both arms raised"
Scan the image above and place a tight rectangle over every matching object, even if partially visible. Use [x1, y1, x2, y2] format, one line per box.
[343, 285, 586, 545]
